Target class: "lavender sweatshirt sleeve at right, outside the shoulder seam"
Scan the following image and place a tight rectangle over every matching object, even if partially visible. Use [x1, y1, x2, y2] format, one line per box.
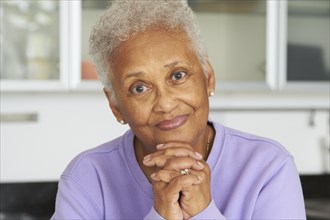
[252, 157, 306, 220]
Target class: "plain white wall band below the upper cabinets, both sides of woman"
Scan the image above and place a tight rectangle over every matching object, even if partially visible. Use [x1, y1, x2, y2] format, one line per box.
[0, 92, 329, 182]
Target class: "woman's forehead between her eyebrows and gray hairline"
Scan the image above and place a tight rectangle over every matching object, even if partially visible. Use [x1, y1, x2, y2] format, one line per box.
[110, 29, 197, 75]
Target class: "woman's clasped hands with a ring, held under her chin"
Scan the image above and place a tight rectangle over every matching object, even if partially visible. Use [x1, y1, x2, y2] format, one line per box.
[143, 142, 211, 219]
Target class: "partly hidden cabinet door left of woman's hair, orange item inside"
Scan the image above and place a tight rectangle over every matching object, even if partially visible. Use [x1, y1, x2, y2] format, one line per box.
[70, 0, 105, 91]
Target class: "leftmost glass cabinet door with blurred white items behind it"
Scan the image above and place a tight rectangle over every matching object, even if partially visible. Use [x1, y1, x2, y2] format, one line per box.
[0, 0, 67, 91]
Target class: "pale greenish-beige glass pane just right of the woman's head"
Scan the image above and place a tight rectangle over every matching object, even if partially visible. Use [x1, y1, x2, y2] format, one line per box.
[197, 13, 266, 82]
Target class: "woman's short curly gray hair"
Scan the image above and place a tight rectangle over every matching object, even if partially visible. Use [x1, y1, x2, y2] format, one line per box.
[89, 0, 207, 93]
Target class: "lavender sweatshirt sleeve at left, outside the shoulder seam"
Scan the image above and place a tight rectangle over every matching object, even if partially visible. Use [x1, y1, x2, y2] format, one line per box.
[51, 175, 103, 220]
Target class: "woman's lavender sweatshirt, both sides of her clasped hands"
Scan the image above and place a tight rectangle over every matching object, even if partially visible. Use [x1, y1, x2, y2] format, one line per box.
[52, 123, 306, 219]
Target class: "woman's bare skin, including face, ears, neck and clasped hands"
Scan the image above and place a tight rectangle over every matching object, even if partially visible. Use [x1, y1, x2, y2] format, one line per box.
[105, 29, 215, 219]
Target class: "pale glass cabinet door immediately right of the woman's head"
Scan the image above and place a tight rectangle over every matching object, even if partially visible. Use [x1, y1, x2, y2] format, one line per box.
[188, 0, 269, 92]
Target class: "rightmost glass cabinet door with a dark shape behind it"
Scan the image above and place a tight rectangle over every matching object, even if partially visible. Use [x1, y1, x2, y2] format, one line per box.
[281, 0, 330, 91]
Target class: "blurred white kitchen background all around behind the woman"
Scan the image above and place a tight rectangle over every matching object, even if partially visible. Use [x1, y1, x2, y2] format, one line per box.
[0, 0, 330, 219]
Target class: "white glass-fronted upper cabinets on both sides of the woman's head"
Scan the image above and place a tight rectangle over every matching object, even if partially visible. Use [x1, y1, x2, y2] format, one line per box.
[0, 0, 330, 93]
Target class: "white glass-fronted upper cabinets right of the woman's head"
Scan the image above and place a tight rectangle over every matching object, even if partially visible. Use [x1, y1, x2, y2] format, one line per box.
[192, 0, 330, 93]
